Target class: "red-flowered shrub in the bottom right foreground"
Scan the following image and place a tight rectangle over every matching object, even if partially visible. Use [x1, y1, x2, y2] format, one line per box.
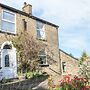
[60, 75, 86, 90]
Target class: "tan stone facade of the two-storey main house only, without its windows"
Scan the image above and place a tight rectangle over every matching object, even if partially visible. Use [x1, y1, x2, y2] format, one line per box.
[0, 3, 60, 75]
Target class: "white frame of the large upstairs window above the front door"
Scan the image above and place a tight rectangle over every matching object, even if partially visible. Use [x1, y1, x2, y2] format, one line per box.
[1, 9, 16, 34]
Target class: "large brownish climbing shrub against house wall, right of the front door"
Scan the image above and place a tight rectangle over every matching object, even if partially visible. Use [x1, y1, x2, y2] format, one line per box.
[12, 31, 42, 72]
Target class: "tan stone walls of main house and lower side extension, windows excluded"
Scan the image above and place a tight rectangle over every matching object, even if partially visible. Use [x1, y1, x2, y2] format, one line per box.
[0, 3, 78, 79]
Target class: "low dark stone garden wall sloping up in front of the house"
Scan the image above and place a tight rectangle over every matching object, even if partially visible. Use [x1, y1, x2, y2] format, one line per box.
[0, 76, 48, 90]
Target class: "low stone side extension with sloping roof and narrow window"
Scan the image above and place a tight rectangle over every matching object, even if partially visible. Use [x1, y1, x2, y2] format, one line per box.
[59, 49, 79, 75]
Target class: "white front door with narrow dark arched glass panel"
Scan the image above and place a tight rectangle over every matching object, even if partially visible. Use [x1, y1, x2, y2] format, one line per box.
[1, 49, 17, 78]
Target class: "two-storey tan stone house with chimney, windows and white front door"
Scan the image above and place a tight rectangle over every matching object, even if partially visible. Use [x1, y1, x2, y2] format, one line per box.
[0, 2, 61, 79]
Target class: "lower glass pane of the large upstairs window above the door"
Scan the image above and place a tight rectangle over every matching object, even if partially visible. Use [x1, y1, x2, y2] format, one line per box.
[2, 20, 15, 32]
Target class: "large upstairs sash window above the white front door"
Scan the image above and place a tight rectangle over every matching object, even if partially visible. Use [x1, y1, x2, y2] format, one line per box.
[1, 10, 15, 34]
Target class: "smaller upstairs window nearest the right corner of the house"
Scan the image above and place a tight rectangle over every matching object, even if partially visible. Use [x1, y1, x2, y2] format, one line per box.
[36, 21, 45, 39]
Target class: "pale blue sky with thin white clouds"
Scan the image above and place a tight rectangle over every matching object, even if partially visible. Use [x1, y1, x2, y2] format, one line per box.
[0, 0, 90, 58]
